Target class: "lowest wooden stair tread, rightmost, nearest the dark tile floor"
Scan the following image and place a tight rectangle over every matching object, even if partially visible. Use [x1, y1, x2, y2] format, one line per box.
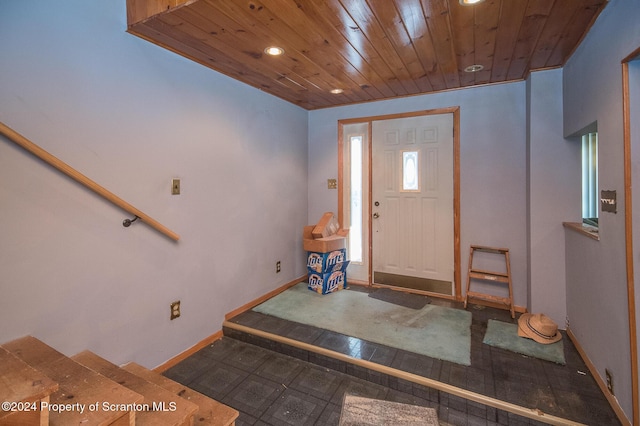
[122, 362, 239, 426]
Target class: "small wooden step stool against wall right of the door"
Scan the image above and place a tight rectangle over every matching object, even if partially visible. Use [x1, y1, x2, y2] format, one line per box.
[464, 245, 516, 318]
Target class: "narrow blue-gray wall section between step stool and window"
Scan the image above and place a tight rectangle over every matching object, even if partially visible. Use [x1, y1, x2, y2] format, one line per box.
[527, 69, 581, 328]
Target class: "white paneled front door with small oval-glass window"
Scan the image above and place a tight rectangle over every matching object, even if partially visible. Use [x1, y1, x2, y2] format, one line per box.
[371, 113, 455, 295]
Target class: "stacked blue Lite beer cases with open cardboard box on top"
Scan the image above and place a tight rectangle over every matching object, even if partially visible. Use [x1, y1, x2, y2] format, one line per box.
[303, 212, 349, 294]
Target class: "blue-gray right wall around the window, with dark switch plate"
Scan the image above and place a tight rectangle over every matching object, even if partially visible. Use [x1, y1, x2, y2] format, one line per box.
[563, 0, 640, 417]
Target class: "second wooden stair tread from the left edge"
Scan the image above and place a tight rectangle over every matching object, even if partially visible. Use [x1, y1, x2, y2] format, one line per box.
[2, 336, 143, 425]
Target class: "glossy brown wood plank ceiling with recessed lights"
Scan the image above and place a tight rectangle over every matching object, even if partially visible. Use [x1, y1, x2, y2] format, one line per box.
[127, 0, 607, 110]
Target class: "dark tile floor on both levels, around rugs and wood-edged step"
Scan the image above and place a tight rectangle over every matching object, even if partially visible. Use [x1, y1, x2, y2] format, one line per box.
[165, 287, 620, 425]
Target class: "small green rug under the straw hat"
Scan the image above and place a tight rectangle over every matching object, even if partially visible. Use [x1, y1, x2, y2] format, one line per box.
[482, 320, 566, 365]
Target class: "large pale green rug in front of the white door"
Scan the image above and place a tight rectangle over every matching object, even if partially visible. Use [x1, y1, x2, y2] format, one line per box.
[253, 283, 471, 365]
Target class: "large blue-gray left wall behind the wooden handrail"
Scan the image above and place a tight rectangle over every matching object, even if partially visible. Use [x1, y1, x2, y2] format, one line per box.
[0, 0, 307, 367]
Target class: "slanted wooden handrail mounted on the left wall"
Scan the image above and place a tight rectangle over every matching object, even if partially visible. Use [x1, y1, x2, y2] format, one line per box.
[0, 122, 180, 241]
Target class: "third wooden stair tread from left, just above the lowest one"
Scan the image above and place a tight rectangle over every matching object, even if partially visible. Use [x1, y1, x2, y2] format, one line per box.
[71, 351, 198, 426]
